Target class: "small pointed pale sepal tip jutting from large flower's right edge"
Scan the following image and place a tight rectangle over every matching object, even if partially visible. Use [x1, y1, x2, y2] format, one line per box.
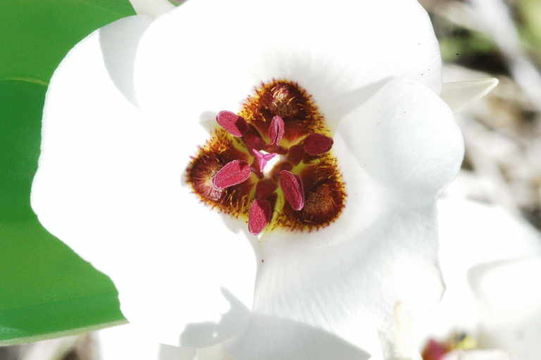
[441, 78, 498, 111]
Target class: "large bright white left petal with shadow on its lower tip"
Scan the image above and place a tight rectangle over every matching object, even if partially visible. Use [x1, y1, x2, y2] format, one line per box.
[32, 18, 255, 346]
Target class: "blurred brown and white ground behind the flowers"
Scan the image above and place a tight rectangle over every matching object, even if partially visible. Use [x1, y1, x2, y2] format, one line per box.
[0, 0, 541, 360]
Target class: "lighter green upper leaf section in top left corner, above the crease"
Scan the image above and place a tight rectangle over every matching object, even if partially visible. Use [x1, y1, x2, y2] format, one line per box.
[0, 0, 134, 83]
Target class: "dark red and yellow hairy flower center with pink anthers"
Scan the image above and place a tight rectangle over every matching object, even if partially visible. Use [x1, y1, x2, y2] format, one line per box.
[186, 80, 346, 234]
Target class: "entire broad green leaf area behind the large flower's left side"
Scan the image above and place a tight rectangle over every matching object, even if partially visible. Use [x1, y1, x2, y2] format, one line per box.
[0, 0, 133, 345]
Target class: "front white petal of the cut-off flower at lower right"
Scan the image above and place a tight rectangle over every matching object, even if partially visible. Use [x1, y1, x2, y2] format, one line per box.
[471, 256, 541, 360]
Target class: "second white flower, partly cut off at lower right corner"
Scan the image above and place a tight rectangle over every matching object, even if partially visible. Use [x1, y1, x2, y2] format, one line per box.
[427, 199, 541, 360]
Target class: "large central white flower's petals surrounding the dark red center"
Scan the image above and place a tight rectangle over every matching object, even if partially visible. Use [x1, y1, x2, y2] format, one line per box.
[32, 0, 493, 360]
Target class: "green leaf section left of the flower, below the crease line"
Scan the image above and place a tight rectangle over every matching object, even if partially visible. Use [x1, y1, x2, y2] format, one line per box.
[0, 81, 122, 344]
